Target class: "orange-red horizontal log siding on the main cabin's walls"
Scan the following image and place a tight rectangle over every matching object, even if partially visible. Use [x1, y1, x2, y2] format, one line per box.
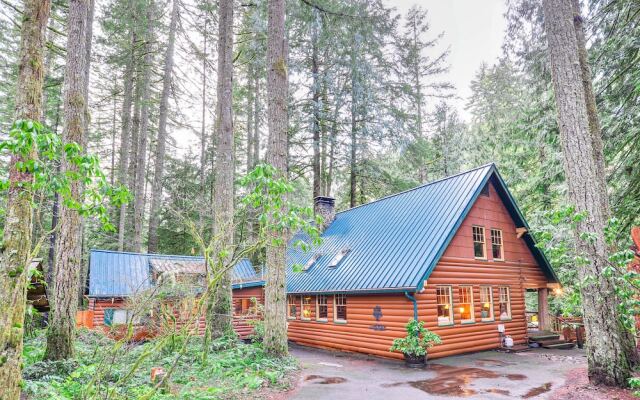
[289, 181, 547, 358]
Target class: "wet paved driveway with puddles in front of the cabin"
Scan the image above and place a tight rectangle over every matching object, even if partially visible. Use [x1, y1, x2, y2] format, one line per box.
[287, 346, 586, 400]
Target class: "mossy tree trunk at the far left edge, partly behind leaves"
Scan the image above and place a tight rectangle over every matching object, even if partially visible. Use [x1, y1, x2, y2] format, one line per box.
[0, 0, 51, 400]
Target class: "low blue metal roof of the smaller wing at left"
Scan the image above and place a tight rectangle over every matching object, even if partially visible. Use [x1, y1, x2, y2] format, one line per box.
[89, 250, 262, 297]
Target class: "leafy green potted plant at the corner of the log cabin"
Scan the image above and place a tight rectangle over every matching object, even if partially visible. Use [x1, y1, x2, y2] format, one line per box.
[389, 319, 442, 368]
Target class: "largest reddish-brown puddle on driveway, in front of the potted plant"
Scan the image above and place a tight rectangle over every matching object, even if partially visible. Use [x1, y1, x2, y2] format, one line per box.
[384, 364, 532, 397]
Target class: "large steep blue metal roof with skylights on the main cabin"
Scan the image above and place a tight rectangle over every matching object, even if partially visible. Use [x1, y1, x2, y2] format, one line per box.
[287, 164, 557, 293]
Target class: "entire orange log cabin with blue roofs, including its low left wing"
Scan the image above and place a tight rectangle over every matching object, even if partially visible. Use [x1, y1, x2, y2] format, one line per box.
[89, 164, 559, 358]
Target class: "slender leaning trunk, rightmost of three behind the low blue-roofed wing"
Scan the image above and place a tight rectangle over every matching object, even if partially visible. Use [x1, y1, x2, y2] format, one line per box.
[148, 0, 179, 253]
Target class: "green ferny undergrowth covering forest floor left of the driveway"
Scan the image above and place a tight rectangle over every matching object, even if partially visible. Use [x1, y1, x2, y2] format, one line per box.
[23, 330, 298, 400]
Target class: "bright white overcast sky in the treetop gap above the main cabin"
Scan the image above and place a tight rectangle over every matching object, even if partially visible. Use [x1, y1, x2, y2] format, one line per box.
[385, 0, 506, 117]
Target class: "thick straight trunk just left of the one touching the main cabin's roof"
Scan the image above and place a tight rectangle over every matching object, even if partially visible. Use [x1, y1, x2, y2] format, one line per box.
[207, 0, 234, 338]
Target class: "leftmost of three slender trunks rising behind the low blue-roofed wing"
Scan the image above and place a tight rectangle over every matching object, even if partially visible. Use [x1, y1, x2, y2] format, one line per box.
[118, 25, 138, 251]
